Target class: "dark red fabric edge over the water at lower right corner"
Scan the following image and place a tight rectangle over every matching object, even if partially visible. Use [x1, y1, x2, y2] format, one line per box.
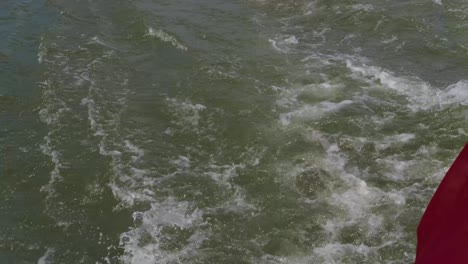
[415, 144, 468, 264]
